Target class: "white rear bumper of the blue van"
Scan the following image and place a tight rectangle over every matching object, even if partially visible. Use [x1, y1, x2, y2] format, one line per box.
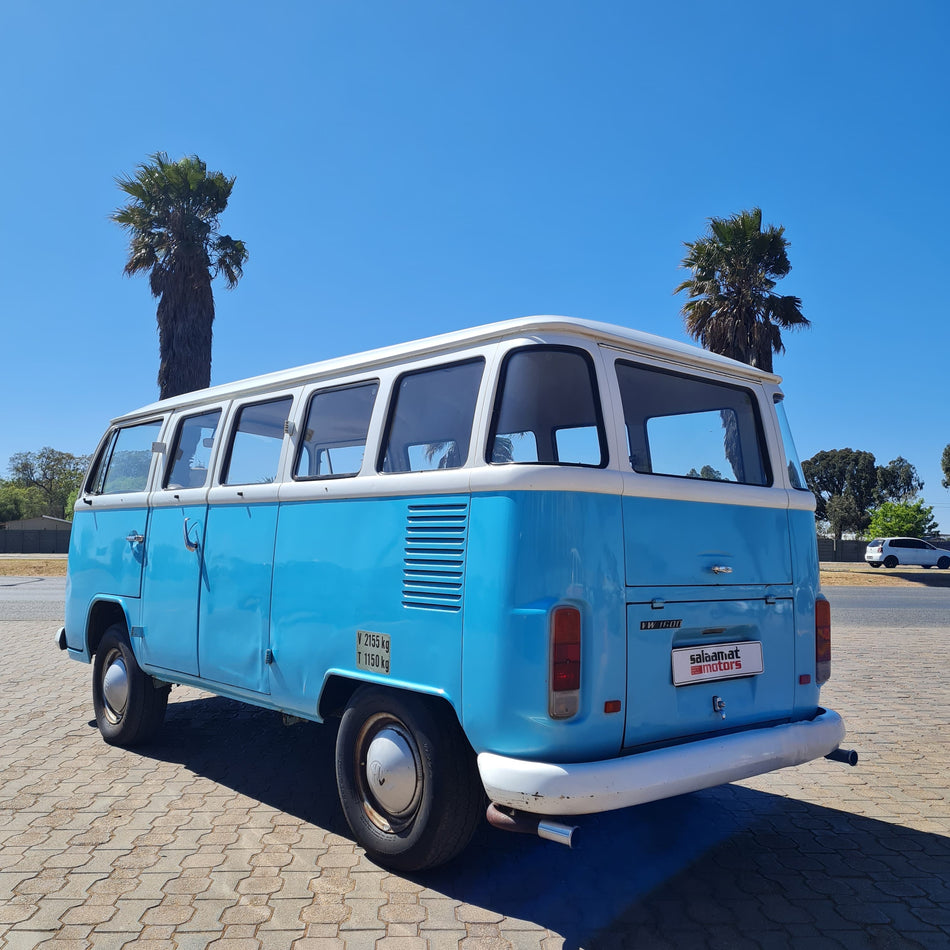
[478, 709, 845, 815]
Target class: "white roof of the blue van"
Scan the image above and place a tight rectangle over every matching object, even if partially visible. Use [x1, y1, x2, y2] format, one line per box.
[114, 316, 781, 421]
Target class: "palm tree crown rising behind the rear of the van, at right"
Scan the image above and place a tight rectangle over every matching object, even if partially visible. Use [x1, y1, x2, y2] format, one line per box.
[673, 208, 809, 372]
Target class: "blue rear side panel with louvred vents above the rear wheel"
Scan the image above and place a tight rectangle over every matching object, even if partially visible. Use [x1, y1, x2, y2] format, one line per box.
[270, 495, 468, 717]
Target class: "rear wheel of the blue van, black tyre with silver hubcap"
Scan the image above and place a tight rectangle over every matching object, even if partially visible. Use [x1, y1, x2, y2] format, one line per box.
[336, 686, 486, 871]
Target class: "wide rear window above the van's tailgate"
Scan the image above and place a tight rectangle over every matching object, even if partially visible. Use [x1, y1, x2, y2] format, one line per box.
[617, 360, 772, 485]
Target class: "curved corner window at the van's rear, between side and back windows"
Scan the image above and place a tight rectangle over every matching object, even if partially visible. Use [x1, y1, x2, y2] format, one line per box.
[488, 346, 607, 467]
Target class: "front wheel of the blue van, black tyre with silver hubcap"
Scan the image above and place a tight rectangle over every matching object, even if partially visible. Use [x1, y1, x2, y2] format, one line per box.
[92, 624, 171, 747]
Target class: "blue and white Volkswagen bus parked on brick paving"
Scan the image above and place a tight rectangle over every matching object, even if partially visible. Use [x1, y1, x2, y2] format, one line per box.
[58, 317, 853, 869]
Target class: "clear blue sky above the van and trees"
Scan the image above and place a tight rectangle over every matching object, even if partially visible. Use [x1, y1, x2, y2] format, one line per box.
[0, 0, 950, 531]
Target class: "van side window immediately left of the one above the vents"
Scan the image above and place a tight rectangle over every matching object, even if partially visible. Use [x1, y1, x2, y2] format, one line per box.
[294, 380, 379, 479]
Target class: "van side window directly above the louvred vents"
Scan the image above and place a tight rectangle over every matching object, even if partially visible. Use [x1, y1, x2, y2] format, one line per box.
[379, 359, 485, 472]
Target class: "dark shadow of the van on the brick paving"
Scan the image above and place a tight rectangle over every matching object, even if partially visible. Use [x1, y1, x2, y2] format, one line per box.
[142, 697, 950, 950]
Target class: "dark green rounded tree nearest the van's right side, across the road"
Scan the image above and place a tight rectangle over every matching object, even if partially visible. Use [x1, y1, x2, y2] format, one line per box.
[802, 449, 877, 541]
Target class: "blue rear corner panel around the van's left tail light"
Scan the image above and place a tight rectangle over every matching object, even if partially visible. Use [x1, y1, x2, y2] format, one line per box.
[462, 491, 626, 762]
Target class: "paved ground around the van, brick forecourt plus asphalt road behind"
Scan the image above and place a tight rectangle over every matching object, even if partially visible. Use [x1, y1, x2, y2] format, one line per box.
[0, 578, 950, 950]
